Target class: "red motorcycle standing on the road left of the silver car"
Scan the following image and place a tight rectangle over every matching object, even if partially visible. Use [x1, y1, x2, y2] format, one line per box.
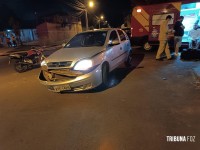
[9, 48, 45, 73]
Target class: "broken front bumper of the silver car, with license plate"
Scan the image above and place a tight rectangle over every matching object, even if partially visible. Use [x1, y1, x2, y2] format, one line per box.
[39, 65, 102, 92]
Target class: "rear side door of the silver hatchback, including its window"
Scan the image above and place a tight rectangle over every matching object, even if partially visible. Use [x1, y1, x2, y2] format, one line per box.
[117, 30, 130, 62]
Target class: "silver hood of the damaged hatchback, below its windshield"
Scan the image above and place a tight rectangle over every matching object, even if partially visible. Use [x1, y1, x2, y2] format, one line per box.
[46, 46, 104, 62]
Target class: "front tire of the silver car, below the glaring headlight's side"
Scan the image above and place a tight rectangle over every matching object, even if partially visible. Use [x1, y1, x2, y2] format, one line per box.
[102, 63, 109, 88]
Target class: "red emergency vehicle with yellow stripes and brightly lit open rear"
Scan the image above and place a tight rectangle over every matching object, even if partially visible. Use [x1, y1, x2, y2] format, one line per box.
[131, 0, 200, 50]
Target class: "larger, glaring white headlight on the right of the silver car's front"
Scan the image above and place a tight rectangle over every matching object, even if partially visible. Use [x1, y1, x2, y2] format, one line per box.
[74, 59, 93, 71]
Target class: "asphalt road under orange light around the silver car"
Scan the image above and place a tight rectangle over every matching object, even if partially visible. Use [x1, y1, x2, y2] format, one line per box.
[0, 49, 200, 150]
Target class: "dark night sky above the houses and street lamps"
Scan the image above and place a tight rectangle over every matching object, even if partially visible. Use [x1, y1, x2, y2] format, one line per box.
[0, 0, 175, 29]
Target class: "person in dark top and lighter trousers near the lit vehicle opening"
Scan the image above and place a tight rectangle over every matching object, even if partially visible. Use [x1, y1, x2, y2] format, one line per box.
[174, 16, 185, 56]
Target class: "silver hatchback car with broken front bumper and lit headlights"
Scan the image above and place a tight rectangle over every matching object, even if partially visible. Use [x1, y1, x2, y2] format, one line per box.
[39, 29, 132, 92]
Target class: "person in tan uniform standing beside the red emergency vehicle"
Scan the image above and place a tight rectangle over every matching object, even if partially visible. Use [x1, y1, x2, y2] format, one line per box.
[156, 15, 172, 60]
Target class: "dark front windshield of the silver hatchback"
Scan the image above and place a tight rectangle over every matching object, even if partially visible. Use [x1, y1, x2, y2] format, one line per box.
[65, 31, 107, 48]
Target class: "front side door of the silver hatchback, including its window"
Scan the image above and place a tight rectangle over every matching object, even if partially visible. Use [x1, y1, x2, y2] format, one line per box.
[108, 30, 121, 70]
